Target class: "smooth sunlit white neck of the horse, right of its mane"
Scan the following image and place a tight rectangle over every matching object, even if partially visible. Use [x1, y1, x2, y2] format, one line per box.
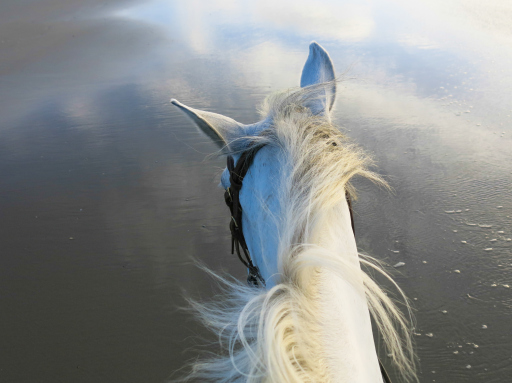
[304, 200, 382, 383]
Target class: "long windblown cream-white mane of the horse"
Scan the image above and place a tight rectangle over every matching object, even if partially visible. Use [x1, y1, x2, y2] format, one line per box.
[178, 84, 417, 383]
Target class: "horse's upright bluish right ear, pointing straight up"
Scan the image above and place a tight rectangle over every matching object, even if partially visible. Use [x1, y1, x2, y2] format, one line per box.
[300, 41, 336, 114]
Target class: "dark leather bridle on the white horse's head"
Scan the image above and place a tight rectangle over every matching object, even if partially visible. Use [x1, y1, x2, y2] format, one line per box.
[224, 145, 391, 383]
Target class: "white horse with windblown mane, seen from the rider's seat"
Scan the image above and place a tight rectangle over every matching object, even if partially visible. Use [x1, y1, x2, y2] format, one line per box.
[171, 42, 417, 383]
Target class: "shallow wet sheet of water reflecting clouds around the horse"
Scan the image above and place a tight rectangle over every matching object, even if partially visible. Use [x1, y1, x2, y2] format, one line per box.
[0, 0, 512, 383]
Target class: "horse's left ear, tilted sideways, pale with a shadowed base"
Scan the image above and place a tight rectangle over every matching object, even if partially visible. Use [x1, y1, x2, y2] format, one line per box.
[171, 98, 244, 149]
